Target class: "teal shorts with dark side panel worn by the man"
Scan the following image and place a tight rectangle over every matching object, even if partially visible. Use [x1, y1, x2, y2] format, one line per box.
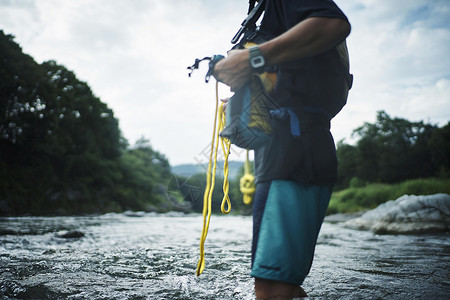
[251, 180, 331, 285]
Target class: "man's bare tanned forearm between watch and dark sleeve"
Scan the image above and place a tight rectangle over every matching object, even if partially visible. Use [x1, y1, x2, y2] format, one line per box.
[259, 18, 350, 65]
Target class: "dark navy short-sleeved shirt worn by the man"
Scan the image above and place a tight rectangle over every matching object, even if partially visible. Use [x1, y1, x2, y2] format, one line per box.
[255, 0, 349, 184]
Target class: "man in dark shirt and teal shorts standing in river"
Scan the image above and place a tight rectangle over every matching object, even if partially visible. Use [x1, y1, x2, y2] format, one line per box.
[214, 0, 352, 299]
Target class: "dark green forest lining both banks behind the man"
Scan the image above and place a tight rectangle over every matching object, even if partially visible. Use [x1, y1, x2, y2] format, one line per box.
[0, 30, 450, 215]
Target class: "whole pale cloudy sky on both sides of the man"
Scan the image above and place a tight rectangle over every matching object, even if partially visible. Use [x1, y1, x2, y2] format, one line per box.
[0, 0, 450, 165]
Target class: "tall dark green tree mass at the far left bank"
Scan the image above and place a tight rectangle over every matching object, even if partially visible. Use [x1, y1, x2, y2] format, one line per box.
[0, 31, 126, 214]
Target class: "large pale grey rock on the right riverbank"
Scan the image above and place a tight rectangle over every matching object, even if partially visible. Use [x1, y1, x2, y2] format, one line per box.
[344, 194, 450, 234]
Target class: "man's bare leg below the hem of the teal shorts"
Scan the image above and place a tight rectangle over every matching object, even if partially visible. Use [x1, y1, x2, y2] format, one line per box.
[255, 278, 308, 300]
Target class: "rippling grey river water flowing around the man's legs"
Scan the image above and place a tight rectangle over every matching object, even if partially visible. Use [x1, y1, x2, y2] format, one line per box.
[0, 213, 450, 299]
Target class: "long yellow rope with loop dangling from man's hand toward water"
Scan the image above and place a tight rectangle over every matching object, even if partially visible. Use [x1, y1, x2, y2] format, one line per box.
[196, 81, 231, 276]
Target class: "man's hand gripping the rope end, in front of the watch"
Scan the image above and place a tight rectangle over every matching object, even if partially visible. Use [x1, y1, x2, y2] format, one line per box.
[214, 49, 252, 92]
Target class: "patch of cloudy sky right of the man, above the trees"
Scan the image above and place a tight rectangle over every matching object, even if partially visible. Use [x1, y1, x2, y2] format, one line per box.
[333, 0, 450, 144]
